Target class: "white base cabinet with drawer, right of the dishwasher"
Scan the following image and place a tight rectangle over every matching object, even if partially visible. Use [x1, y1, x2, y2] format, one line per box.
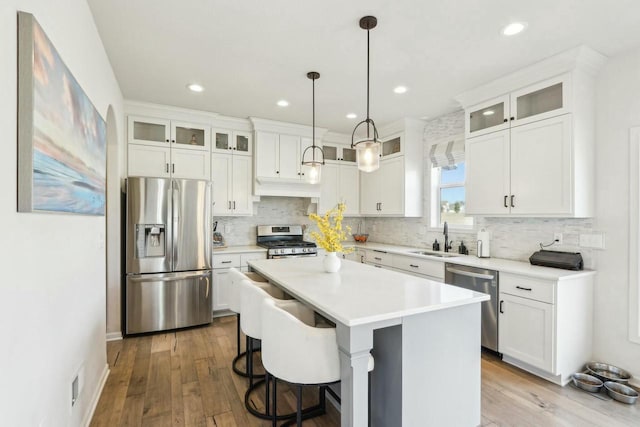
[498, 272, 593, 385]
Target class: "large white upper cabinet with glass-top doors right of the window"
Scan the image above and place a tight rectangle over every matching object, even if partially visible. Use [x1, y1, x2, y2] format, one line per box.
[457, 47, 605, 217]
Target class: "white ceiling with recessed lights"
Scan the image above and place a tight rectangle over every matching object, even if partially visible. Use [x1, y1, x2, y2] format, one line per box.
[88, 0, 640, 133]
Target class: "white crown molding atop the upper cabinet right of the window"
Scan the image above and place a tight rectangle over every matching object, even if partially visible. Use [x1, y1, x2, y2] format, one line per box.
[454, 45, 607, 108]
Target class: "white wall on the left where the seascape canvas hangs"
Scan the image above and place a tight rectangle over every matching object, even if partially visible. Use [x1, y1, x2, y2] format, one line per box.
[0, 0, 123, 427]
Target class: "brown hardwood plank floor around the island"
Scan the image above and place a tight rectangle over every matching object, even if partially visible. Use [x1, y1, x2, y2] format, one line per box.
[91, 317, 640, 427]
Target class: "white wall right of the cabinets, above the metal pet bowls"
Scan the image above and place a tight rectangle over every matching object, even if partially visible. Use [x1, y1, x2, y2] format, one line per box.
[594, 49, 640, 377]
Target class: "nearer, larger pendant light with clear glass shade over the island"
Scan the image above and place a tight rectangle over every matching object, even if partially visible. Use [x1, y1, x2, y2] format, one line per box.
[351, 16, 380, 172]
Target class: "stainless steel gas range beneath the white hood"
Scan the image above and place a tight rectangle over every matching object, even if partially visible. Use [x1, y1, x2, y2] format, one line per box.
[257, 225, 318, 259]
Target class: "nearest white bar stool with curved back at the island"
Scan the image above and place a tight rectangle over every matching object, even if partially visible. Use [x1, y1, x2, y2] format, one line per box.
[262, 299, 374, 427]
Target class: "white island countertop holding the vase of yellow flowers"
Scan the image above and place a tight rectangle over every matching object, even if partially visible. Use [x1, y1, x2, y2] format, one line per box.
[249, 257, 489, 327]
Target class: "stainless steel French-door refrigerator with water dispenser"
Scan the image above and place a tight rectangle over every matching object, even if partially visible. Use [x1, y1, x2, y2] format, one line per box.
[124, 177, 213, 334]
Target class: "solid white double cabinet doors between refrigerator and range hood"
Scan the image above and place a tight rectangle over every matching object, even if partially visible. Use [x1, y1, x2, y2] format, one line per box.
[211, 153, 253, 216]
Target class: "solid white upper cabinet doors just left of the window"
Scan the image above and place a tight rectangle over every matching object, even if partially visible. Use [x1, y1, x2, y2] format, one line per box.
[360, 156, 406, 216]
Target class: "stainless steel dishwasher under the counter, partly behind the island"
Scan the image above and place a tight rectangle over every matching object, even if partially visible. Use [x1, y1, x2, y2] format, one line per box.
[444, 262, 498, 352]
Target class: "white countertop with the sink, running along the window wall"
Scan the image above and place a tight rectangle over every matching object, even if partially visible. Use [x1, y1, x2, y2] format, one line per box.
[354, 242, 596, 281]
